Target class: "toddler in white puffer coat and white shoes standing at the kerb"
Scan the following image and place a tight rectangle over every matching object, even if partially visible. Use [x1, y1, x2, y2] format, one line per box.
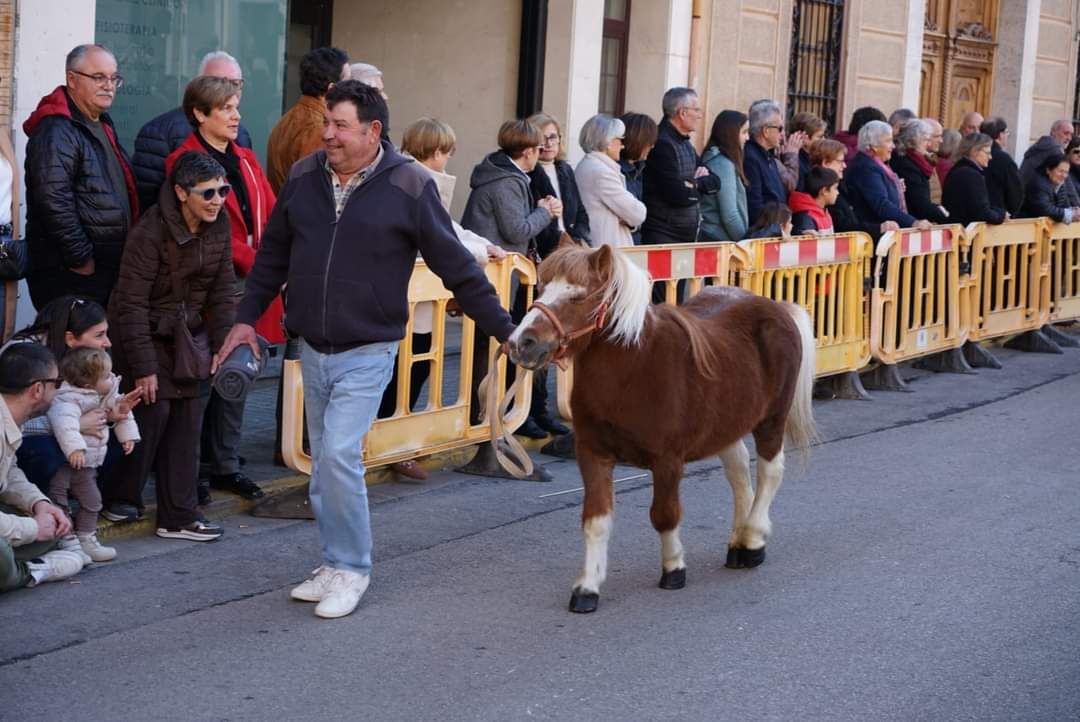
[49, 348, 139, 561]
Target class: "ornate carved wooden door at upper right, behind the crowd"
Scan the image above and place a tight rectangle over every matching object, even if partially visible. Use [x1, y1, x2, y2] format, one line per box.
[919, 0, 999, 127]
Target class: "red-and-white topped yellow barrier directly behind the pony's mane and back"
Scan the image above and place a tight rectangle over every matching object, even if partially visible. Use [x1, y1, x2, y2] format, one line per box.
[556, 243, 750, 420]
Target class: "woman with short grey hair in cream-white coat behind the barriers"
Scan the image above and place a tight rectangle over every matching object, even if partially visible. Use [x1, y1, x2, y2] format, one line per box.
[575, 114, 645, 247]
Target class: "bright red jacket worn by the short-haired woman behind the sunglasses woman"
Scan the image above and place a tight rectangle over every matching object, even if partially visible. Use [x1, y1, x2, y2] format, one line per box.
[165, 133, 285, 343]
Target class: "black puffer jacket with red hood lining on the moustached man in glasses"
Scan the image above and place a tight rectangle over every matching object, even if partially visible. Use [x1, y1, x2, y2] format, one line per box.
[23, 86, 138, 302]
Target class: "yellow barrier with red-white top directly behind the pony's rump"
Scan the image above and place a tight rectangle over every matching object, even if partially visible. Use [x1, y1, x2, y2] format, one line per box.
[740, 233, 874, 378]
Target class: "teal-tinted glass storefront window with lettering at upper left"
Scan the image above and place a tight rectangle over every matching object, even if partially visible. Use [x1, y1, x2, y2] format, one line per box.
[94, 0, 288, 163]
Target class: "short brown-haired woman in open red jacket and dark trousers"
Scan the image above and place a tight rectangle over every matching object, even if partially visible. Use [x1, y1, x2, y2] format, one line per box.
[165, 76, 285, 504]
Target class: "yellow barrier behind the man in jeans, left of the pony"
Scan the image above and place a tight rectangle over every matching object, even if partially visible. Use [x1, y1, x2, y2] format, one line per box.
[282, 254, 537, 474]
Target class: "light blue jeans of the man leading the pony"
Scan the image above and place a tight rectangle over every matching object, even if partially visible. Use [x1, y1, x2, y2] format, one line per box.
[300, 341, 397, 574]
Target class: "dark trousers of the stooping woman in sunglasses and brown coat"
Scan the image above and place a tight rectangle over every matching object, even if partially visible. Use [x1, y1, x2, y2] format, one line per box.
[107, 398, 202, 528]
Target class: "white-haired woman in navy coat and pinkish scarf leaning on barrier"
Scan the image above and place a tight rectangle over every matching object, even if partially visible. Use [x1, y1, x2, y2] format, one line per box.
[845, 121, 930, 229]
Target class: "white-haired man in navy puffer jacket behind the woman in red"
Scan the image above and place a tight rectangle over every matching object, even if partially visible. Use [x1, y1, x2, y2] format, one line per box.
[132, 51, 252, 209]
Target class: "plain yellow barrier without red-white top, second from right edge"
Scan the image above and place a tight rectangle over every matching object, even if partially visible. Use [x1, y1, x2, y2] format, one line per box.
[961, 218, 1050, 341]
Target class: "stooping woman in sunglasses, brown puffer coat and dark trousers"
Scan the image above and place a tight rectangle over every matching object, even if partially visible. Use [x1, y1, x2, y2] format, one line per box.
[109, 152, 237, 542]
